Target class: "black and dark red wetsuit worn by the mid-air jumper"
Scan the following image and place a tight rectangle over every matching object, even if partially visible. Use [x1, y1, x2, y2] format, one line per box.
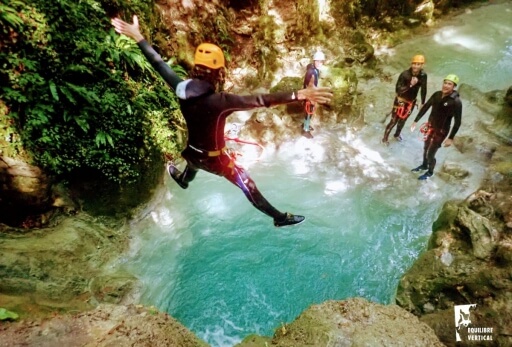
[138, 40, 296, 220]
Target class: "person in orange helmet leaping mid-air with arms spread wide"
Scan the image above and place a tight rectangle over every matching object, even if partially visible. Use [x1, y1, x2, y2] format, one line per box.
[112, 16, 332, 227]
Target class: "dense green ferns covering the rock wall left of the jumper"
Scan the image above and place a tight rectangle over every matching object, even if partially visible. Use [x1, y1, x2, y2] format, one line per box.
[0, 0, 185, 183]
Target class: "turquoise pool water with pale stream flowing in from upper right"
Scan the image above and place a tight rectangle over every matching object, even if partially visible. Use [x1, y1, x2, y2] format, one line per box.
[126, 2, 512, 346]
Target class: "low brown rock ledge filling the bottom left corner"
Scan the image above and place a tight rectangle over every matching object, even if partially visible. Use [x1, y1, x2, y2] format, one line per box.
[0, 304, 208, 347]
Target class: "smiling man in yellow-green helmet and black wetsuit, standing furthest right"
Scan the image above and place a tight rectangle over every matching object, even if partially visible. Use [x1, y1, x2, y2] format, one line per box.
[411, 74, 462, 180]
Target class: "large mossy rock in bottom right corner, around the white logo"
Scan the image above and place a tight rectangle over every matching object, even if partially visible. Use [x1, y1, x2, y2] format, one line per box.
[396, 179, 512, 346]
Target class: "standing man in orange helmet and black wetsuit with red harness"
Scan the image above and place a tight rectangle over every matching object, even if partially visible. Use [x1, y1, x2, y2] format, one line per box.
[382, 55, 427, 146]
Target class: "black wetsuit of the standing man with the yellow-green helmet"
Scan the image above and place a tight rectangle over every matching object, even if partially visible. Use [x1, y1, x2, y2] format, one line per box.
[414, 90, 462, 175]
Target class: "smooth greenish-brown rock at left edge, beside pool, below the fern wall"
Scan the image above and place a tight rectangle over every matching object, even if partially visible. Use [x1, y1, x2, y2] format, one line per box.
[0, 214, 136, 318]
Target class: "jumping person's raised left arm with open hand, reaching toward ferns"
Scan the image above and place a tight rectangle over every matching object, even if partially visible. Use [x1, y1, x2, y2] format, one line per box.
[111, 15, 183, 91]
